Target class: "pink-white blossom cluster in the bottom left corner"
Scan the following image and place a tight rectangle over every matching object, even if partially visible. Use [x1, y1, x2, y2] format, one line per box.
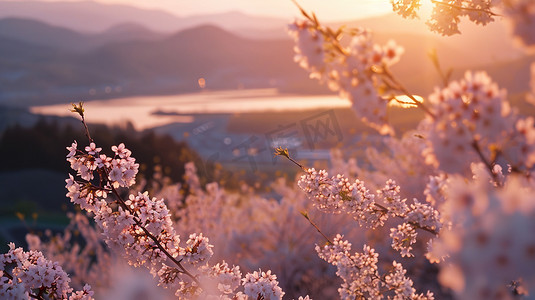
[0, 243, 93, 300]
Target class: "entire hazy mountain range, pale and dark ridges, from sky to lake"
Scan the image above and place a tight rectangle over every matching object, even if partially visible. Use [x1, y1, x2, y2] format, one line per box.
[0, 1, 534, 106]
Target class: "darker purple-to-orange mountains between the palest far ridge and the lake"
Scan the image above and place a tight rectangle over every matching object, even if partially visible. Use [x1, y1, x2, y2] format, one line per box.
[0, 8, 533, 106]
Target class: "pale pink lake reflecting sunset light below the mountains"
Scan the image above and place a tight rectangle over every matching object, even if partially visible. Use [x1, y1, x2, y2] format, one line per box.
[30, 89, 351, 130]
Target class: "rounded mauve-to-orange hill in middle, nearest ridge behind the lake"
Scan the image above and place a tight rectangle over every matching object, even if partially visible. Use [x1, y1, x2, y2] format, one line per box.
[88, 25, 301, 79]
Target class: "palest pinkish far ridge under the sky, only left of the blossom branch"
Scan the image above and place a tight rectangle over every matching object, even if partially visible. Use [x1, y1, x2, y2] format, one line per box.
[0, 0, 287, 33]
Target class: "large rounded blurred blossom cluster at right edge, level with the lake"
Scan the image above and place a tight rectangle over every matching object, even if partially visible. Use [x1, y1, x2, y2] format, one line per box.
[424, 72, 535, 174]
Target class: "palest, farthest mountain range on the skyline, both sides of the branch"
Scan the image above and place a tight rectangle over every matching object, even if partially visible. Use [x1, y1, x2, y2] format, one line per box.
[0, 1, 521, 62]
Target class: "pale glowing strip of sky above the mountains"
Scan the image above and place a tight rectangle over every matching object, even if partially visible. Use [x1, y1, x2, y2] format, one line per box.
[31, 0, 392, 21]
